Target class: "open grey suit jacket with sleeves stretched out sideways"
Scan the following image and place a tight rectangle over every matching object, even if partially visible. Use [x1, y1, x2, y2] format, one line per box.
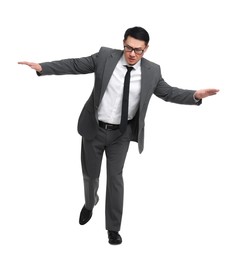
[37, 47, 201, 153]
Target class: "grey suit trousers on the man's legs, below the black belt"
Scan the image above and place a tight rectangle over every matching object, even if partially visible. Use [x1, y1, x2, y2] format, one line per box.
[81, 125, 132, 231]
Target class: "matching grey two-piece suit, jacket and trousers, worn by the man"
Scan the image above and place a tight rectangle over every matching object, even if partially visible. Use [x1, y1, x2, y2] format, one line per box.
[38, 47, 201, 231]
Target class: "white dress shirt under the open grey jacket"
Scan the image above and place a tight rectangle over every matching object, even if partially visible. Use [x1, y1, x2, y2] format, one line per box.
[98, 56, 141, 124]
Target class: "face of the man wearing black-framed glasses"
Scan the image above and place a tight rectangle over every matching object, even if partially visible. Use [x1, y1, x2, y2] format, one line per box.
[124, 36, 148, 65]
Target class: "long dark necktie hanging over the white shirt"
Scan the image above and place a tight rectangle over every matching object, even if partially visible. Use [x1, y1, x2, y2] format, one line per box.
[119, 66, 133, 133]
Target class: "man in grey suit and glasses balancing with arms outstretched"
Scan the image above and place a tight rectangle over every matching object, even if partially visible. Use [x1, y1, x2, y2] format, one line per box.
[19, 27, 219, 245]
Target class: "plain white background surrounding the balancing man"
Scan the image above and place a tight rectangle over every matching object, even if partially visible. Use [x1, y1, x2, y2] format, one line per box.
[0, 0, 242, 260]
